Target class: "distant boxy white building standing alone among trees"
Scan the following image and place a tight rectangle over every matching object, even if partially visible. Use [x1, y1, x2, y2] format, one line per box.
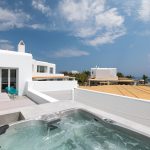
[91, 68, 118, 80]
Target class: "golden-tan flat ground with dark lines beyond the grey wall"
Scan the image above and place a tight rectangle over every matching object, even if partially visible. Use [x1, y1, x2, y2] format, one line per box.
[80, 85, 150, 100]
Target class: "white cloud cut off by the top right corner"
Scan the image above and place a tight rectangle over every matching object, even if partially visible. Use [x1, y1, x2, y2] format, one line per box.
[139, 0, 150, 22]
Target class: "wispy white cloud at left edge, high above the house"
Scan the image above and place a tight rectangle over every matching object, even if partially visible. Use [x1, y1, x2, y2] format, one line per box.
[0, 7, 30, 31]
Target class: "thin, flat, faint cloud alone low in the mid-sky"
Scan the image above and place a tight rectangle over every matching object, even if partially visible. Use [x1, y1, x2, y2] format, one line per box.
[54, 49, 89, 57]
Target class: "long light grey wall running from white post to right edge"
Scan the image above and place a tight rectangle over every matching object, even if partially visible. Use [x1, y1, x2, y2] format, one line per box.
[74, 88, 150, 126]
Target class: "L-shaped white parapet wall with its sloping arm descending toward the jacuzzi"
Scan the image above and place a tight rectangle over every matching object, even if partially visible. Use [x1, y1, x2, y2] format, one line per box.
[26, 80, 78, 104]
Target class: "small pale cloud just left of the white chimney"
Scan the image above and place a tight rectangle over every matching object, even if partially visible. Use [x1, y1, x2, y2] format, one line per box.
[0, 39, 15, 50]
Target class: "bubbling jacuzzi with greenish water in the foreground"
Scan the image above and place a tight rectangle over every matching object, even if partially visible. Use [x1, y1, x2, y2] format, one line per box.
[0, 109, 150, 150]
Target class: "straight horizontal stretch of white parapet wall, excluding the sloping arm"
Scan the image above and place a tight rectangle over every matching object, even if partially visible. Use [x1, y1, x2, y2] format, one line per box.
[28, 80, 78, 92]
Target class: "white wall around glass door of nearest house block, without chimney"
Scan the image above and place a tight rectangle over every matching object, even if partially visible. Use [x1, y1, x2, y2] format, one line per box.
[0, 50, 32, 95]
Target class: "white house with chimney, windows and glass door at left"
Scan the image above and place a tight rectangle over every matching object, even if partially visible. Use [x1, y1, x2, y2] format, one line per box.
[0, 41, 64, 95]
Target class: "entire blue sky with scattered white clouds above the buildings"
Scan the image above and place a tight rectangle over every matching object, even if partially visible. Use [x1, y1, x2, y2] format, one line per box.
[0, 0, 150, 76]
